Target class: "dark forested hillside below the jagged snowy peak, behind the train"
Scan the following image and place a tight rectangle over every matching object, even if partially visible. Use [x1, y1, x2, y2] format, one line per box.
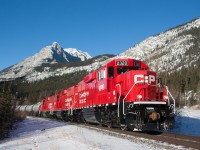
[0, 71, 87, 104]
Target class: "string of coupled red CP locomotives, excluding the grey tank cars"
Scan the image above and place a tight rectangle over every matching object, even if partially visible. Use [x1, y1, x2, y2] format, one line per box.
[18, 58, 175, 130]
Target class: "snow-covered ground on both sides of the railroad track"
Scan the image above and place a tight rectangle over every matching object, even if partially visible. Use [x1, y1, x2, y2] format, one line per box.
[0, 108, 200, 150]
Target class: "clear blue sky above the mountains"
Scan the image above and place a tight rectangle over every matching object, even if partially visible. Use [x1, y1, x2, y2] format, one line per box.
[0, 0, 200, 70]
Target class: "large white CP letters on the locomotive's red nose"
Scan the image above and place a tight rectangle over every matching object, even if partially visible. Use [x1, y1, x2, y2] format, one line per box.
[134, 74, 156, 84]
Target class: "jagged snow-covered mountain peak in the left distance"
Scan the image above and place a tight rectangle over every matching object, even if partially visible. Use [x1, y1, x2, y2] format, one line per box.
[0, 42, 92, 80]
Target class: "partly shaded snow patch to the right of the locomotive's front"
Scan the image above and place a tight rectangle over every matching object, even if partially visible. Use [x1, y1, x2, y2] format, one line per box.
[170, 107, 200, 136]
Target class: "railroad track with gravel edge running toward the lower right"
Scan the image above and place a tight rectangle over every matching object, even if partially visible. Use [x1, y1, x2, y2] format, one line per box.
[77, 124, 200, 149]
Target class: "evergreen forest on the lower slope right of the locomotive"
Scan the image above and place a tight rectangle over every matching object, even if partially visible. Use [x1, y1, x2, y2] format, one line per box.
[159, 56, 200, 106]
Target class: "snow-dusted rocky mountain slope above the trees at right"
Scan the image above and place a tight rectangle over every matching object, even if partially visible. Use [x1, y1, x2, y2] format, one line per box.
[120, 18, 200, 72]
